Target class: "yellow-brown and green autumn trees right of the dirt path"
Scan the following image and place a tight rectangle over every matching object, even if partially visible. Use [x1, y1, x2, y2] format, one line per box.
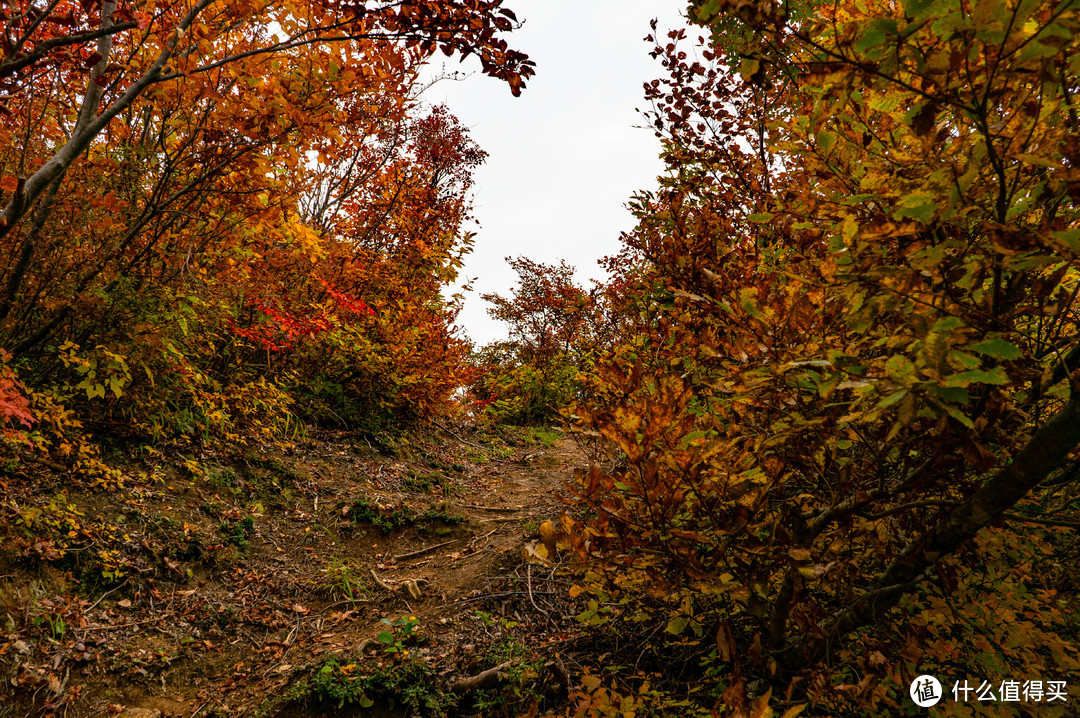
[575, 1, 1080, 710]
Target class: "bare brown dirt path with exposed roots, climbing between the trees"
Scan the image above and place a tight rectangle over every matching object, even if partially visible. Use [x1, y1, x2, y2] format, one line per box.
[0, 427, 584, 718]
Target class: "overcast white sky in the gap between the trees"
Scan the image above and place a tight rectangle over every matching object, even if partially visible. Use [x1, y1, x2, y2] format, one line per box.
[424, 0, 686, 344]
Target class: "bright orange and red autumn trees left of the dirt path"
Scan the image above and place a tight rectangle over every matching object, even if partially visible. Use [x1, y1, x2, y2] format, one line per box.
[0, 0, 532, 456]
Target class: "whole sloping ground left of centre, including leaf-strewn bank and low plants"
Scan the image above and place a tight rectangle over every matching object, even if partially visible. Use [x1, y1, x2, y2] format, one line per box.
[0, 428, 585, 718]
